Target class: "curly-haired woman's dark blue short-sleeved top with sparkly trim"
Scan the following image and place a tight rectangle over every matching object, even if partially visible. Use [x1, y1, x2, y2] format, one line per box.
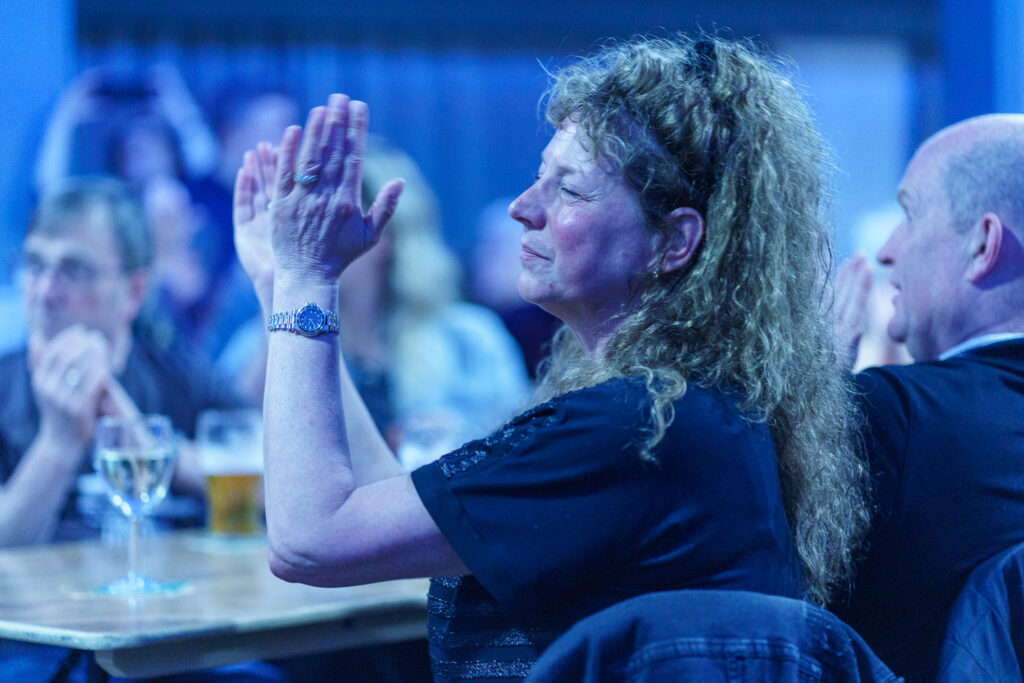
[413, 380, 803, 680]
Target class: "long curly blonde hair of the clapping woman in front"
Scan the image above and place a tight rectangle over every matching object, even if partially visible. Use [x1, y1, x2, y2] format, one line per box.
[538, 36, 868, 604]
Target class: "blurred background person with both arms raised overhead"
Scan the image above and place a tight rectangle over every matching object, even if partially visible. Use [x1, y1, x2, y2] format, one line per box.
[36, 65, 241, 358]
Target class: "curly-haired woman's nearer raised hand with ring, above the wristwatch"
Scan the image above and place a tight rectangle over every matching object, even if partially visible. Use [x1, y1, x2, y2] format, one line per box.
[270, 94, 404, 284]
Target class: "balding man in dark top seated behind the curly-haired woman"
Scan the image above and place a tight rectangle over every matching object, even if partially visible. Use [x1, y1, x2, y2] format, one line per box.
[835, 115, 1024, 682]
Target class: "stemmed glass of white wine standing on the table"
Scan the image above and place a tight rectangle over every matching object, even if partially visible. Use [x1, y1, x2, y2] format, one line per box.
[93, 415, 183, 595]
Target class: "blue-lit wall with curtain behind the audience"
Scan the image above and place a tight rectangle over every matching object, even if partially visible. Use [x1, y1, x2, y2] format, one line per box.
[0, 0, 1024, 280]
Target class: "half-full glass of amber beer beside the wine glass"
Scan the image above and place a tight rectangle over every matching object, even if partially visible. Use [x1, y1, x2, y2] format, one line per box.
[196, 410, 263, 537]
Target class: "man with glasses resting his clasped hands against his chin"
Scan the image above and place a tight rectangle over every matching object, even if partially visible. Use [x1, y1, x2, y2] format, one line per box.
[0, 178, 240, 546]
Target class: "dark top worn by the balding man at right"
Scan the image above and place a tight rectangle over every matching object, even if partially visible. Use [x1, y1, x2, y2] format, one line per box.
[834, 340, 1024, 683]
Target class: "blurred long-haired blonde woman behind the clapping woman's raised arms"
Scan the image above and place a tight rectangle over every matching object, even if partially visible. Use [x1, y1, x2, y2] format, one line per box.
[221, 137, 530, 469]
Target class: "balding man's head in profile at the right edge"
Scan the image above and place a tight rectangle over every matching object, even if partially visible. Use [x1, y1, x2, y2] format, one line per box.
[878, 115, 1024, 360]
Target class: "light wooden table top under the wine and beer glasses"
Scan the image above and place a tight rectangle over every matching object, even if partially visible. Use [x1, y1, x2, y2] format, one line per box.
[0, 532, 427, 677]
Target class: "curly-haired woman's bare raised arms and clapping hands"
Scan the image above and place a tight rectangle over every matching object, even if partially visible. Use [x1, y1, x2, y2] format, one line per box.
[236, 95, 466, 586]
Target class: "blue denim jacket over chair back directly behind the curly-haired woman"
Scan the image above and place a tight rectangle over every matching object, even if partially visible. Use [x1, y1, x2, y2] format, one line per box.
[526, 591, 901, 683]
